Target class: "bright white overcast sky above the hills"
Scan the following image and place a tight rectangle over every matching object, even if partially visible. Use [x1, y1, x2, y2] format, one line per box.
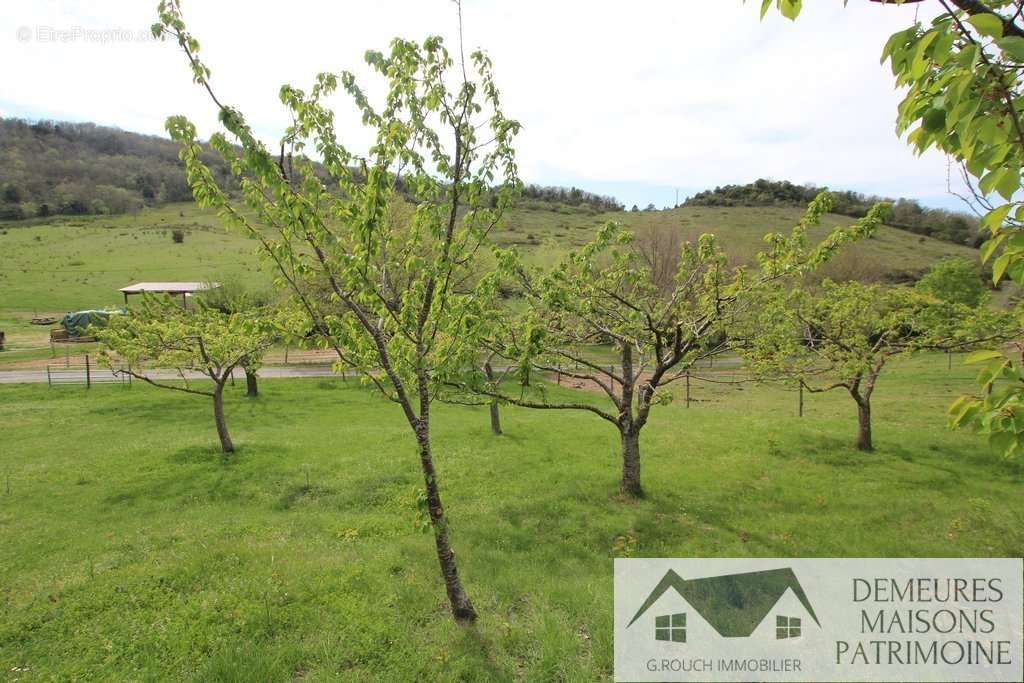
[0, 0, 964, 209]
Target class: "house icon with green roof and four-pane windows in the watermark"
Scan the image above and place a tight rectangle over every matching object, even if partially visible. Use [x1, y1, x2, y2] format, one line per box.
[627, 568, 821, 643]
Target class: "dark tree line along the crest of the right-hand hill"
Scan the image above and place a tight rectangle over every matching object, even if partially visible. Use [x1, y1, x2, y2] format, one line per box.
[684, 178, 985, 248]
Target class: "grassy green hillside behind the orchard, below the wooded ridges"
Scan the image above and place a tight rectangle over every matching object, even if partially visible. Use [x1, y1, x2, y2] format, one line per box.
[0, 203, 977, 313]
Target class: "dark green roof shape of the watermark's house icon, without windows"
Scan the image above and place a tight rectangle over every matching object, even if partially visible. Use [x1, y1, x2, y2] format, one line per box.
[627, 567, 821, 638]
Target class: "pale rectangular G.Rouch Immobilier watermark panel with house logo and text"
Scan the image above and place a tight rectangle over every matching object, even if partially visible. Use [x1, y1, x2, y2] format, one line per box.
[614, 559, 1024, 682]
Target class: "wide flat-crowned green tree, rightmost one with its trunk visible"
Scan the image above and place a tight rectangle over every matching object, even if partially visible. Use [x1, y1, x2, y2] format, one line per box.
[737, 280, 1008, 451]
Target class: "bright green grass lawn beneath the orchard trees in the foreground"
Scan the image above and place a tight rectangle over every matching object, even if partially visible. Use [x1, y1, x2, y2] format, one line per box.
[0, 356, 1024, 682]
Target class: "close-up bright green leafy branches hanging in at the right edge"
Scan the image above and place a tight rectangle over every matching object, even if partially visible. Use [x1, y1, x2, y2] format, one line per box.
[761, 0, 1024, 453]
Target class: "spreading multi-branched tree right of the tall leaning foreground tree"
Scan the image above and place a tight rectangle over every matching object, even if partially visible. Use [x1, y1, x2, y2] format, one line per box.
[477, 193, 885, 497]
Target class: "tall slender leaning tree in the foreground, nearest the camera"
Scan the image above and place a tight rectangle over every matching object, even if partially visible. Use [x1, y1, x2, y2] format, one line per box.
[154, 0, 519, 621]
